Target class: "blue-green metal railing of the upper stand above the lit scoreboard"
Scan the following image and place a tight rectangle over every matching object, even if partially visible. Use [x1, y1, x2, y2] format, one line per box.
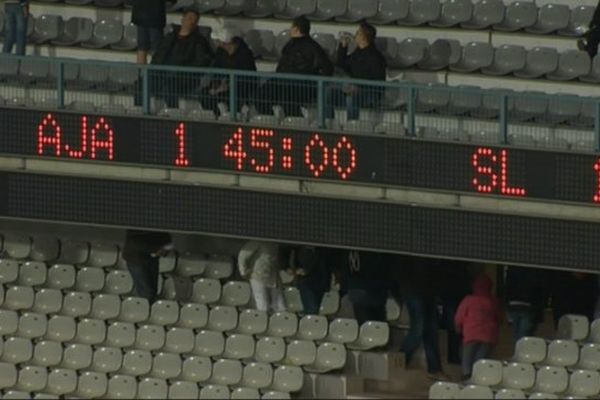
[0, 55, 600, 151]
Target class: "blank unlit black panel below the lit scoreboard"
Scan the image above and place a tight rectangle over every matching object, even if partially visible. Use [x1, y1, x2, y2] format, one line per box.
[0, 172, 600, 271]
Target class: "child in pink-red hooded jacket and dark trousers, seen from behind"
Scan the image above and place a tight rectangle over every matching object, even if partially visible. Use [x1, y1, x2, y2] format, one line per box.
[454, 274, 501, 379]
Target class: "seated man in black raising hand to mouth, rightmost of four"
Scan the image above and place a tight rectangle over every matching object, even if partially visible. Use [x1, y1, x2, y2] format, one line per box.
[326, 22, 386, 120]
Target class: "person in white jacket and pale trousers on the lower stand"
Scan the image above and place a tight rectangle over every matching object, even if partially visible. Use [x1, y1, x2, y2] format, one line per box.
[238, 240, 285, 312]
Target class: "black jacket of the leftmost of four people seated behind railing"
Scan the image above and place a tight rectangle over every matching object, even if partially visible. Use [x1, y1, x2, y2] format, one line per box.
[152, 26, 214, 67]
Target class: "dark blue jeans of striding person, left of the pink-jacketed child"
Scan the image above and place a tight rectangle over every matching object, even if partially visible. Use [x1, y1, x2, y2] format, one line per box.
[402, 295, 442, 374]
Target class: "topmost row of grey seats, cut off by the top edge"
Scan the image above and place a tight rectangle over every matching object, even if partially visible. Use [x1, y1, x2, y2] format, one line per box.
[35, 0, 594, 36]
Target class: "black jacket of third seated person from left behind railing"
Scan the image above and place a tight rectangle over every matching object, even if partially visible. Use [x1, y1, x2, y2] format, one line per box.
[277, 36, 333, 76]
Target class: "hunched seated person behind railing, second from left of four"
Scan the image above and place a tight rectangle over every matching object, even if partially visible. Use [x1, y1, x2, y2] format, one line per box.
[202, 28, 256, 113]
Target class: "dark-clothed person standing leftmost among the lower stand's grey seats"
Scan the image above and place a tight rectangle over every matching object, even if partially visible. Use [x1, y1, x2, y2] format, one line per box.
[123, 229, 173, 304]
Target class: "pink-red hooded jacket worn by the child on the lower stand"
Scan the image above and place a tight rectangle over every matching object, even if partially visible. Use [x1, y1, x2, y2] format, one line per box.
[454, 274, 501, 344]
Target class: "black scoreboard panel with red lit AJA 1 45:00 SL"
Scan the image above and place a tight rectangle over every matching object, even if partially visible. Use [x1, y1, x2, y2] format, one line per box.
[0, 108, 600, 204]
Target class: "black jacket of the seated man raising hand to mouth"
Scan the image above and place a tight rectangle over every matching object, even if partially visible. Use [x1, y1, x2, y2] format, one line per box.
[337, 45, 386, 81]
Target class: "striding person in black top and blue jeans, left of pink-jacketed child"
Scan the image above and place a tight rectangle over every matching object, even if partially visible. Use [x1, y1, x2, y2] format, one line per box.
[400, 258, 446, 379]
